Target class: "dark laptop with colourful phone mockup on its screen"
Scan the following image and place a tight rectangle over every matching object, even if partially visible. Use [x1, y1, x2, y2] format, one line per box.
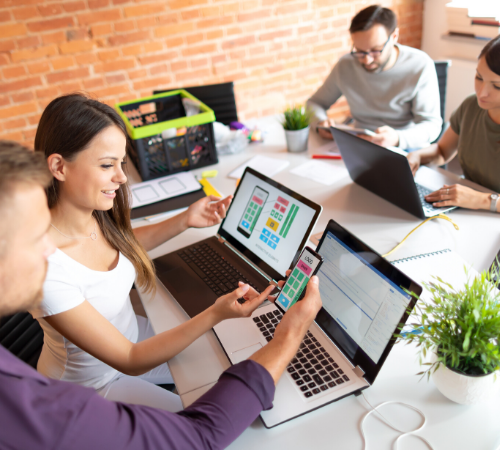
[154, 167, 322, 317]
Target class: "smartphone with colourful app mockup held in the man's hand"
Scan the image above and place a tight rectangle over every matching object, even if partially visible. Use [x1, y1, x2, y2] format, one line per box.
[275, 247, 323, 312]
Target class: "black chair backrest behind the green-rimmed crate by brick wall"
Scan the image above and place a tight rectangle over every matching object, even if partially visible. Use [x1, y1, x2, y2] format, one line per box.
[153, 81, 238, 125]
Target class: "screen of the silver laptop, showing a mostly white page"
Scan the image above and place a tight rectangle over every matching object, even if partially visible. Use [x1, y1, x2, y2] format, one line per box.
[317, 222, 421, 384]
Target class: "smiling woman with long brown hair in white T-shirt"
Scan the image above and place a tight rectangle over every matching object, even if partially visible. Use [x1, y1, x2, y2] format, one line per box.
[31, 94, 272, 411]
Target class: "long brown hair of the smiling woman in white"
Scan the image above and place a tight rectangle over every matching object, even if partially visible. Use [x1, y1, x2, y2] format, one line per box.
[35, 93, 156, 291]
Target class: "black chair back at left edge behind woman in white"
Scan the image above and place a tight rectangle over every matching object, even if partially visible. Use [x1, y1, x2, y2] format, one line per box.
[0, 312, 43, 369]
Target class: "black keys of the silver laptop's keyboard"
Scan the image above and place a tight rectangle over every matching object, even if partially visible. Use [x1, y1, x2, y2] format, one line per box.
[253, 310, 349, 398]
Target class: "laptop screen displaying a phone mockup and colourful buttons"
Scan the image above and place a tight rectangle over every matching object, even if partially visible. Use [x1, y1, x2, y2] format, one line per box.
[219, 169, 321, 277]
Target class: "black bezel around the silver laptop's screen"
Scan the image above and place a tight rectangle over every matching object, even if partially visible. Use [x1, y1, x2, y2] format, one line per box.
[315, 220, 422, 384]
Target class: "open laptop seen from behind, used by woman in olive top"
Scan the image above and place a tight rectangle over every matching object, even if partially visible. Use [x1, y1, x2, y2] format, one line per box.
[331, 127, 464, 219]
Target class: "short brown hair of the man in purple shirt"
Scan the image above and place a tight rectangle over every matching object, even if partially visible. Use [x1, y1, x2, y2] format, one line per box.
[0, 140, 52, 206]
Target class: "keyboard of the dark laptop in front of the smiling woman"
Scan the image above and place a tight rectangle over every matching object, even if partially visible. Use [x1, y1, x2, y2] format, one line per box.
[178, 244, 255, 296]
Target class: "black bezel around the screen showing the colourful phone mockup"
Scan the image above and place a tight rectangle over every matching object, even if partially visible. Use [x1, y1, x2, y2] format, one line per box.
[218, 167, 323, 281]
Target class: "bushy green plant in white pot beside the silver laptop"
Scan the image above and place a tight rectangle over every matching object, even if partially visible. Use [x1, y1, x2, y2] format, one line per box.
[397, 266, 500, 405]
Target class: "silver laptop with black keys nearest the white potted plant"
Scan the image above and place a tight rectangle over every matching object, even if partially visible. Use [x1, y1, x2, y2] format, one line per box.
[214, 220, 422, 428]
